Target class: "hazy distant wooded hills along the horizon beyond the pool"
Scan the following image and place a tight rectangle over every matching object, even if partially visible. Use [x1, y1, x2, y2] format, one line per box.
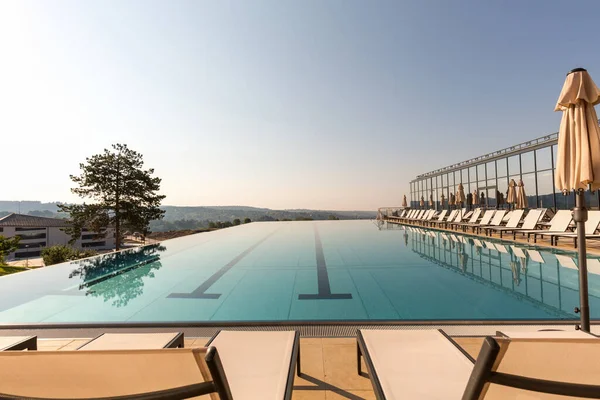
[0, 201, 377, 232]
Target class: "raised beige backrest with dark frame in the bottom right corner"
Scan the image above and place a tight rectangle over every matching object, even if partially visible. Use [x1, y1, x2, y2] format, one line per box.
[462, 337, 600, 400]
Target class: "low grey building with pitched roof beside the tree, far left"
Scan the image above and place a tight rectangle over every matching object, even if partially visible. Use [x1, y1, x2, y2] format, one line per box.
[0, 213, 115, 260]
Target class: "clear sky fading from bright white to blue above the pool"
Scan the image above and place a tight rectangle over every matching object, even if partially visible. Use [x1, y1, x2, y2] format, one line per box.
[0, 0, 600, 210]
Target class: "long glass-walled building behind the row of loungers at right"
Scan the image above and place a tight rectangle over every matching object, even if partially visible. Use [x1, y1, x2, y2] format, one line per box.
[410, 133, 599, 210]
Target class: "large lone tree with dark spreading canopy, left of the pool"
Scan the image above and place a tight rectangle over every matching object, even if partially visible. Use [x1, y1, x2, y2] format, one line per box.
[59, 144, 165, 250]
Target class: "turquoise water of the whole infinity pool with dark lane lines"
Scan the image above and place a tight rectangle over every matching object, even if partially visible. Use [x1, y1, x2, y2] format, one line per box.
[0, 221, 600, 324]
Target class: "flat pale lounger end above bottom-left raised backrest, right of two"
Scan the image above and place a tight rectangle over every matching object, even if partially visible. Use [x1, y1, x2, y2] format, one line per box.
[77, 332, 183, 350]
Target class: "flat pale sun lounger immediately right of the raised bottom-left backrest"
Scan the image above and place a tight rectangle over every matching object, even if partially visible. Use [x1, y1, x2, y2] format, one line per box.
[207, 331, 300, 400]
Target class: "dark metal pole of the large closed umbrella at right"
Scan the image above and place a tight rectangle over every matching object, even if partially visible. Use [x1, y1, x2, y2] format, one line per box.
[573, 189, 590, 332]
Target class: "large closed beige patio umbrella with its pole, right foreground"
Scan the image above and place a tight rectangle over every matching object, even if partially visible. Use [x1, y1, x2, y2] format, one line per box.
[554, 68, 600, 332]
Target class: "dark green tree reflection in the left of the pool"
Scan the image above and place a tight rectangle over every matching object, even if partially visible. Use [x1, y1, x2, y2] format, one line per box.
[69, 244, 166, 307]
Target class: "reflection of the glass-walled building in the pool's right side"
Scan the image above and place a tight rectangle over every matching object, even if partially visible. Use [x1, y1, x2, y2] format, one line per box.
[409, 231, 600, 319]
